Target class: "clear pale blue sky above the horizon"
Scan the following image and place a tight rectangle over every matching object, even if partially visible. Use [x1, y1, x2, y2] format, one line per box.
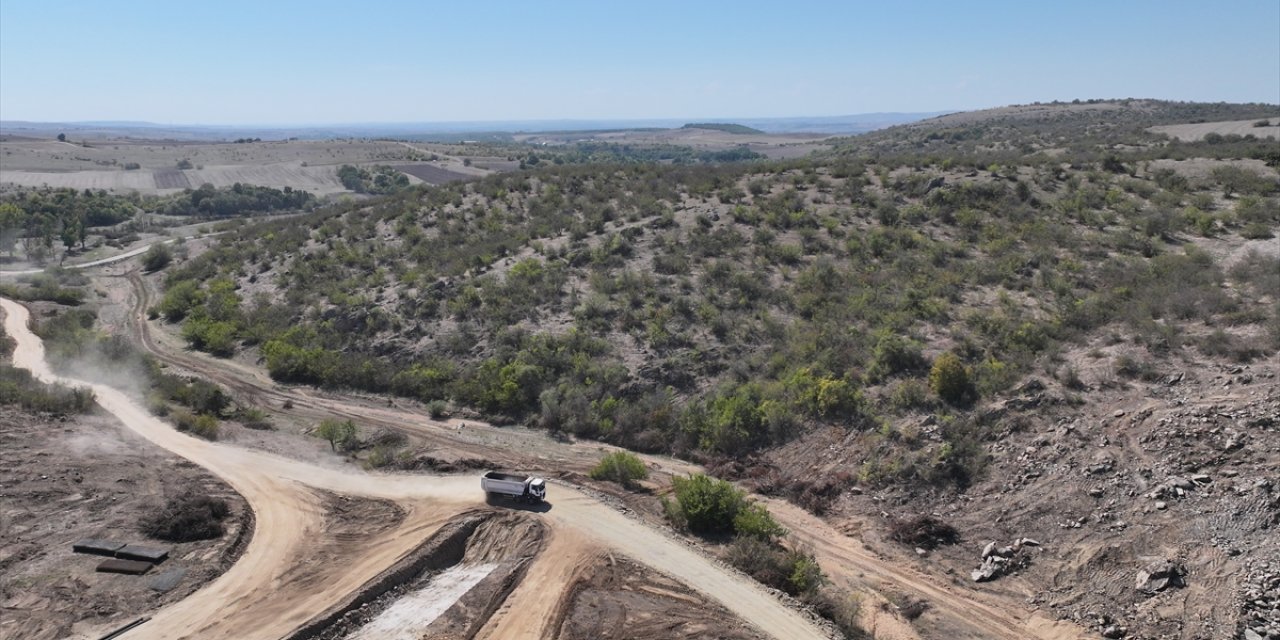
[0, 0, 1280, 124]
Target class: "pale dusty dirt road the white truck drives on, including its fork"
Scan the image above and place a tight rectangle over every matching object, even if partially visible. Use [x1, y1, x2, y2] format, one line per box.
[0, 298, 824, 639]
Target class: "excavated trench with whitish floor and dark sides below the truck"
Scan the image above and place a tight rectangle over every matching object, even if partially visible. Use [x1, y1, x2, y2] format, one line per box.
[288, 509, 545, 640]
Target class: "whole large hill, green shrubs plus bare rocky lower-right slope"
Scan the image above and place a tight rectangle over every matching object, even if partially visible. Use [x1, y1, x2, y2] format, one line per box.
[10, 101, 1280, 639]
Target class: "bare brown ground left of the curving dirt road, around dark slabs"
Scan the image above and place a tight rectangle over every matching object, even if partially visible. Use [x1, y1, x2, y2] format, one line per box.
[0, 407, 248, 640]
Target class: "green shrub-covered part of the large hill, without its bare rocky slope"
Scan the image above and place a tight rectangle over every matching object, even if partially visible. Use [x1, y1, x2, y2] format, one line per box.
[129, 97, 1280, 640]
